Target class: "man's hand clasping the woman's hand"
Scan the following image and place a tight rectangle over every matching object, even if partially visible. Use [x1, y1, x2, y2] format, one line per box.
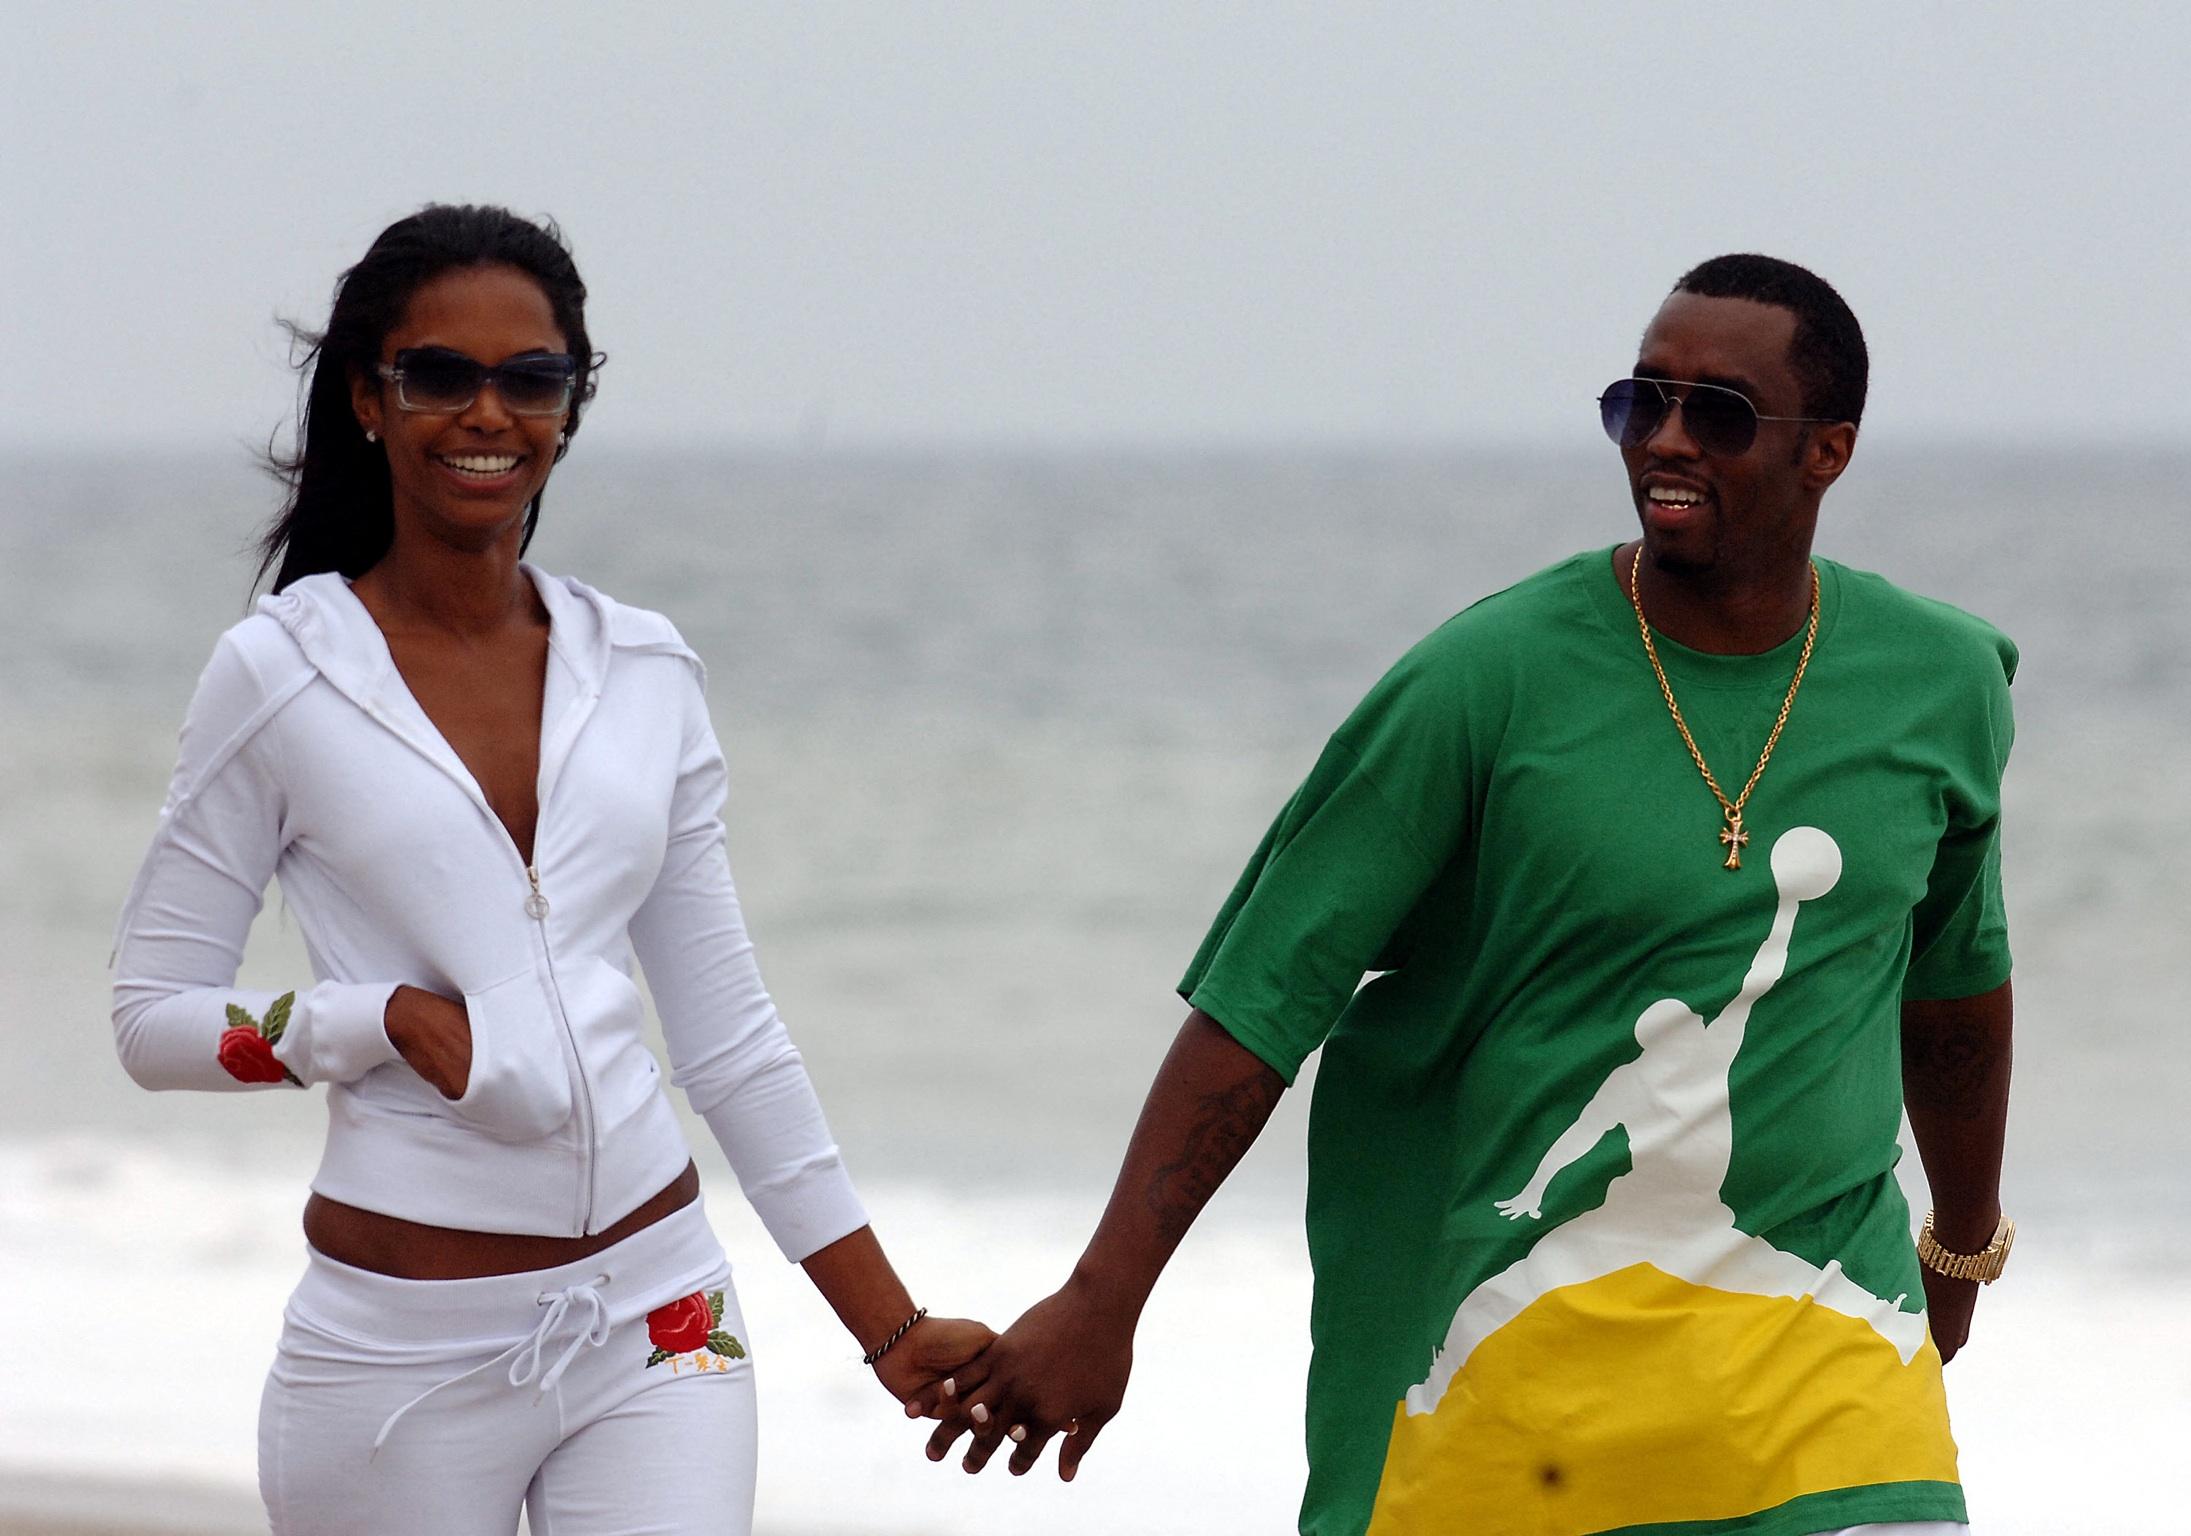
[907, 1277, 1137, 1481]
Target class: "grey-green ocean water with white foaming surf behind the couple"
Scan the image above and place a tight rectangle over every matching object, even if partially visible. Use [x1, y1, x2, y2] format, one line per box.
[0, 449, 2191, 1532]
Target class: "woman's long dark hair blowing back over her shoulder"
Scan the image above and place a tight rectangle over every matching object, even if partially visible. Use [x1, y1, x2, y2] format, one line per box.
[256, 204, 603, 592]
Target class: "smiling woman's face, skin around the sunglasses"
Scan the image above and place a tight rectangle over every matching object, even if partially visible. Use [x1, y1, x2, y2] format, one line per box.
[351, 265, 570, 550]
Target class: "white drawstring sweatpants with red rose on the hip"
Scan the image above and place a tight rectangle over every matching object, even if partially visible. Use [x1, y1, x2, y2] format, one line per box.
[259, 1201, 756, 1536]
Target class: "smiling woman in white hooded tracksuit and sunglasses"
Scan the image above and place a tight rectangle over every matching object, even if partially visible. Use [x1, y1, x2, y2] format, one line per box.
[114, 206, 990, 1536]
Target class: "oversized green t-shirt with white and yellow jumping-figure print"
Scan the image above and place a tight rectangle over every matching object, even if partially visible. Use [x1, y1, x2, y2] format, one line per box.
[1181, 550, 2016, 1536]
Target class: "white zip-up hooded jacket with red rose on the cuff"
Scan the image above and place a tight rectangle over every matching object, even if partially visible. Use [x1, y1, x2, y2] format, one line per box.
[114, 568, 868, 1258]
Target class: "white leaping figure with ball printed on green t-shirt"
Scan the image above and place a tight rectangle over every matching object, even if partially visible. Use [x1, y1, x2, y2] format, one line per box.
[1407, 826, 1924, 1413]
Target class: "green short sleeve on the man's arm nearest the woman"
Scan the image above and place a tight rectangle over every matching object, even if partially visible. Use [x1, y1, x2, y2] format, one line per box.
[1179, 620, 1485, 1082]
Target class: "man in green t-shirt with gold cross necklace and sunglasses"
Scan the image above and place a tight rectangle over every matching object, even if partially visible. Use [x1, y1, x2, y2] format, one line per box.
[929, 256, 2016, 1536]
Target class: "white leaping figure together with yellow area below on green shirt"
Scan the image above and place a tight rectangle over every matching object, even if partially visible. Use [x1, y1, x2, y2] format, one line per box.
[1369, 826, 1954, 1536]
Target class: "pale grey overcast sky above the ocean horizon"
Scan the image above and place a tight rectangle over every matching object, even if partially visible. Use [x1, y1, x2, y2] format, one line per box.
[0, 0, 2191, 447]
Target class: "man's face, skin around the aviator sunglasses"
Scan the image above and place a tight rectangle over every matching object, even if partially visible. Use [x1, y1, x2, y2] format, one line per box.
[1621, 294, 1847, 576]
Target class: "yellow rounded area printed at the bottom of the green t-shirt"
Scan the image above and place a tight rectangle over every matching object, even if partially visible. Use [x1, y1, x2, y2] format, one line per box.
[1369, 1264, 1954, 1536]
